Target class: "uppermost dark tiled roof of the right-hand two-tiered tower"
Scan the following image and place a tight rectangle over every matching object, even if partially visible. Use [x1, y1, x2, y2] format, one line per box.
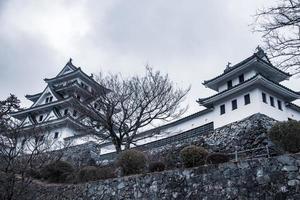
[203, 53, 291, 85]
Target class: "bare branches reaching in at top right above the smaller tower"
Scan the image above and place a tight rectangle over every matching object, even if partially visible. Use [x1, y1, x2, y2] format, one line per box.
[254, 0, 300, 74]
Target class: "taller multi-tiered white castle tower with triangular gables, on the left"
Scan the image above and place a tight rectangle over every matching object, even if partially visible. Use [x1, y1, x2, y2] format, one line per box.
[11, 59, 108, 149]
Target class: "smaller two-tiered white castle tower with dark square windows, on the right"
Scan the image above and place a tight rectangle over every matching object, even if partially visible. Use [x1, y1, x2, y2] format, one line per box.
[197, 47, 300, 128]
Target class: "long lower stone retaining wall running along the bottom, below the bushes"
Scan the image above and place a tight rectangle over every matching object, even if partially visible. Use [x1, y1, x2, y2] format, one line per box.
[27, 154, 300, 200]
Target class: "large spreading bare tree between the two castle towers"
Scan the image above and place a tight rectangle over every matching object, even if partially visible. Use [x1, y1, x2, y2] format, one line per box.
[81, 66, 189, 153]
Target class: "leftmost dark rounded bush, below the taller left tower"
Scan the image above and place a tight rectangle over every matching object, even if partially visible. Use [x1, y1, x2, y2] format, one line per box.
[41, 161, 74, 183]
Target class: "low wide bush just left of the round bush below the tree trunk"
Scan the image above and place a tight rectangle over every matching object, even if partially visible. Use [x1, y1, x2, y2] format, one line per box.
[77, 166, 115, 182]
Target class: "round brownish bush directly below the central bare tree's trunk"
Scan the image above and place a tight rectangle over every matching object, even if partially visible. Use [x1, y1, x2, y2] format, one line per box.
[117, 149, 147, 175]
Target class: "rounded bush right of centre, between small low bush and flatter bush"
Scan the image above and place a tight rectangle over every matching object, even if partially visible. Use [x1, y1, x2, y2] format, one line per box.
[180, 145, 208, 167]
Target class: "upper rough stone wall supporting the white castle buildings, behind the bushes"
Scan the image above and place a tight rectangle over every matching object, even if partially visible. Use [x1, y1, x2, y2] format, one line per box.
[54, 114, 276, 166]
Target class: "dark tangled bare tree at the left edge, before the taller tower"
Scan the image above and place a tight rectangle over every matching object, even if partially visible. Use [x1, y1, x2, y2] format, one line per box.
[0, 95, 60, 200]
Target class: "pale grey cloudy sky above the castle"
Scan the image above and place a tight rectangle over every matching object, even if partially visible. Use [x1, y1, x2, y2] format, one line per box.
[0, 0, 300, 113]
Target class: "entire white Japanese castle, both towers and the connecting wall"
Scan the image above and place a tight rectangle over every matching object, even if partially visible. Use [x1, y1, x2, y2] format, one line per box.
[12, 47, 300, 154]
